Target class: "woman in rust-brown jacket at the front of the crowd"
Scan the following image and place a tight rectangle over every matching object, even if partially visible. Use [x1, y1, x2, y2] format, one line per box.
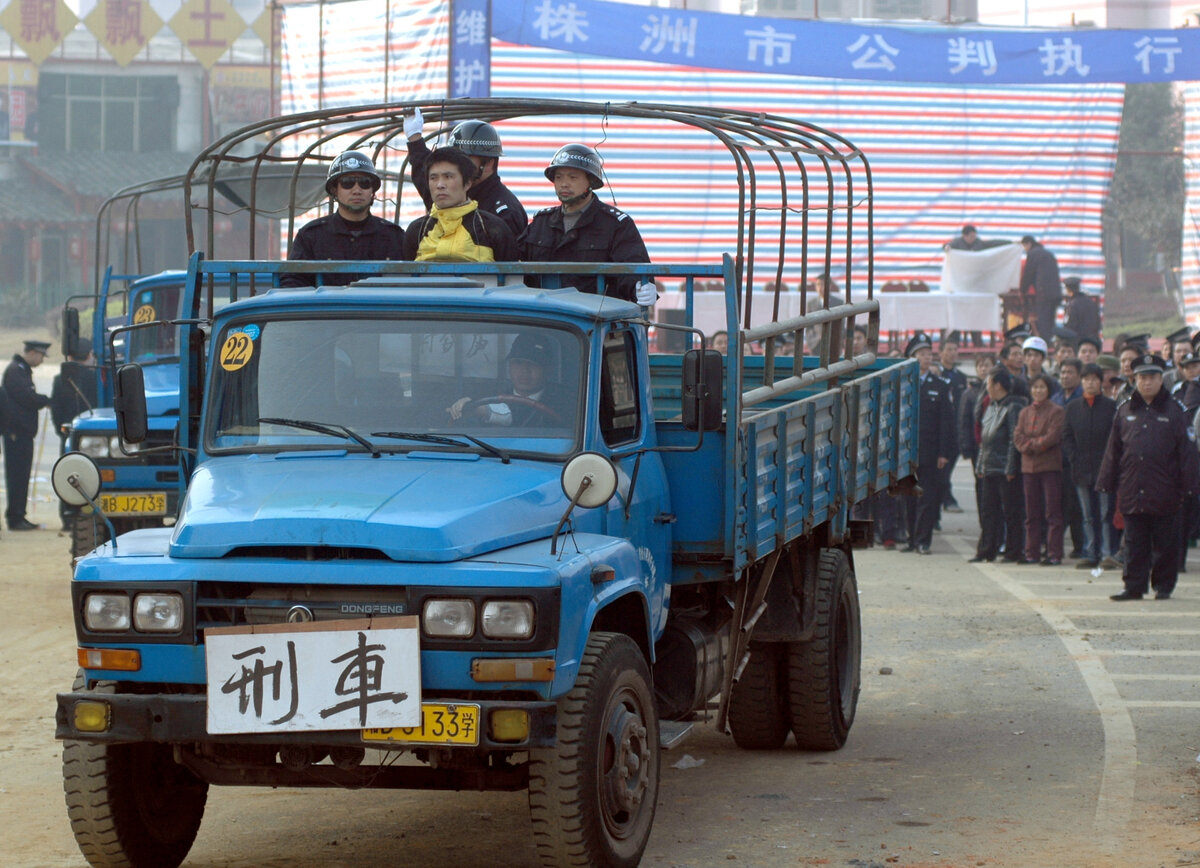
[1013, 373, 1067, 567]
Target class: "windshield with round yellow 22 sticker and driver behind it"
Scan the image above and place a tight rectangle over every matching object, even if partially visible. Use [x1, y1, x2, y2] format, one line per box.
[205, 317, 584, 457]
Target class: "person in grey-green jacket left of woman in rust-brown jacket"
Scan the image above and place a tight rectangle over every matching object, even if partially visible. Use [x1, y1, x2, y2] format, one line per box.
[971, 366, 1026, 563]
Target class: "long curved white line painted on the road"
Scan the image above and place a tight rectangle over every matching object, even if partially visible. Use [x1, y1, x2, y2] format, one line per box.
[942, 537, 1132, 852]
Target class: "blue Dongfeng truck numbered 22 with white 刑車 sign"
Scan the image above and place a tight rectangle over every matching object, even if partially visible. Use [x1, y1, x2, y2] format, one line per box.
[54, 101, 917, 866]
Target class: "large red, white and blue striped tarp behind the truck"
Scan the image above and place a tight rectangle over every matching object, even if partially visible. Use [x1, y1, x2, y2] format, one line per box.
[283, 0, 1123, 312]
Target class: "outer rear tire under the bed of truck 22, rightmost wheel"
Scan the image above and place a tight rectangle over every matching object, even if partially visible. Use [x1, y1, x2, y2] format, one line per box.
[787, 549, 863, 750]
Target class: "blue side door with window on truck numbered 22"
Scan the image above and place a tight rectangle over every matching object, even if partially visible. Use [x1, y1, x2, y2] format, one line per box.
[600, 328, 671, 635]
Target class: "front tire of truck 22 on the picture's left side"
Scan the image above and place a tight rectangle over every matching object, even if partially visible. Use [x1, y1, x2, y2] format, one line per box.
[62, 677, 209, 868]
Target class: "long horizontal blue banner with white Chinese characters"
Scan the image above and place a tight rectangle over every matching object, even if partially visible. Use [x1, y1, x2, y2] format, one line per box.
[492, 0, 1200, 85]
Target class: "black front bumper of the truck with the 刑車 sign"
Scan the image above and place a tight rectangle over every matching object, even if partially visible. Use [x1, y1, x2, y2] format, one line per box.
[54, 690, 557, 750]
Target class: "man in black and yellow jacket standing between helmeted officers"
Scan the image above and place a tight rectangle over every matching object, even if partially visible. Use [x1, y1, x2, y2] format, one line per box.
[404, 148, 518, 262]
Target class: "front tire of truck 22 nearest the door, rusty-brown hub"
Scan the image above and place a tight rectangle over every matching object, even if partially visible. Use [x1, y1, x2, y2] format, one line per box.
[529, 633, 659, 868]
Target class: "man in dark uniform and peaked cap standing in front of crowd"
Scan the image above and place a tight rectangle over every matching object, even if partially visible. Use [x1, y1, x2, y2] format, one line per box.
[1096, 354, 1200, 601]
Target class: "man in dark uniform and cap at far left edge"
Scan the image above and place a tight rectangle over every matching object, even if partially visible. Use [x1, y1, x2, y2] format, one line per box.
[2, 341, 50, 531]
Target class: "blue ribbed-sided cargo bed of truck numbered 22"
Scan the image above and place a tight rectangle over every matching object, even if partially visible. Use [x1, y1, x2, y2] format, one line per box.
[652, 355, 917, 581]
